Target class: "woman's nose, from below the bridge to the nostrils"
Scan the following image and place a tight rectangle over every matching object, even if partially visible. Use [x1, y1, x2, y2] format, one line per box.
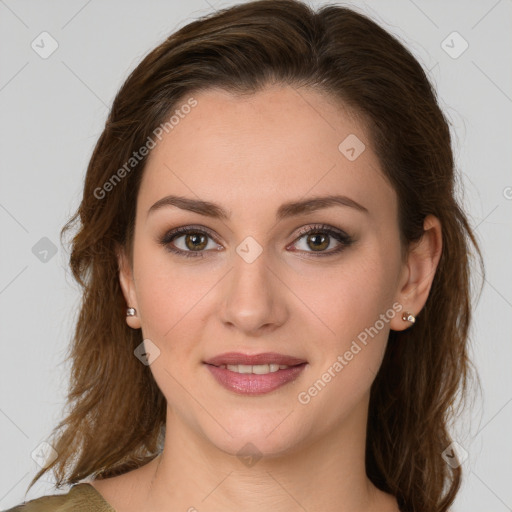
[220, 247, 289, 336]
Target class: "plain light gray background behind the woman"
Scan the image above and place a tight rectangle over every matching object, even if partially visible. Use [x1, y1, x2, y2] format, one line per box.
[0, 0, 512, 512]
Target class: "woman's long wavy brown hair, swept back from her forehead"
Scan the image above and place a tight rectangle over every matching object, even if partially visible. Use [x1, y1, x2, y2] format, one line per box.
[29, 0, 483, 512]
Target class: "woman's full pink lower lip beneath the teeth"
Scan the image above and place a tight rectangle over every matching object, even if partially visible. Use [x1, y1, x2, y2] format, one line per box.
[206, 363, 306, 395]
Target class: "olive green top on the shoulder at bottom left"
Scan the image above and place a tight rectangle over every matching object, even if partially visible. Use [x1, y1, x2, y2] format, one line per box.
[5, 482, 116, 512]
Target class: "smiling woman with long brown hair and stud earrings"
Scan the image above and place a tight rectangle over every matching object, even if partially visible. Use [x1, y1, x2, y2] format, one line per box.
[8, 0, 481, 512]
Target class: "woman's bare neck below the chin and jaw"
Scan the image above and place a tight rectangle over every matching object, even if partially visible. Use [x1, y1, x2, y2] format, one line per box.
[148, 394, 382, 512]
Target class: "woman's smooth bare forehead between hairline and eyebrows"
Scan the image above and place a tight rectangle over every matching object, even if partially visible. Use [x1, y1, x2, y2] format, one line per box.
[138, 86, 395, 224]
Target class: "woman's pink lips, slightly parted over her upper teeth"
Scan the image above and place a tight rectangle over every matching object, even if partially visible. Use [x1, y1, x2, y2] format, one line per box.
[205, 352, 307, 395]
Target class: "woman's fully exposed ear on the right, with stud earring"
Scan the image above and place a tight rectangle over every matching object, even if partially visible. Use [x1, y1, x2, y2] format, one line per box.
[390, 215, 443, 331]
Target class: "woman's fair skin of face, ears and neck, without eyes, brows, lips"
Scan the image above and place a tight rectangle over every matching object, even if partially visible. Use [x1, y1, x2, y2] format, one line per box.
[91, 86, 441, 512]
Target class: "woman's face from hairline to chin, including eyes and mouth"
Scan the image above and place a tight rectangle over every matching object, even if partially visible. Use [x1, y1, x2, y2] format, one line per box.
[120, 86, 414, 454]
